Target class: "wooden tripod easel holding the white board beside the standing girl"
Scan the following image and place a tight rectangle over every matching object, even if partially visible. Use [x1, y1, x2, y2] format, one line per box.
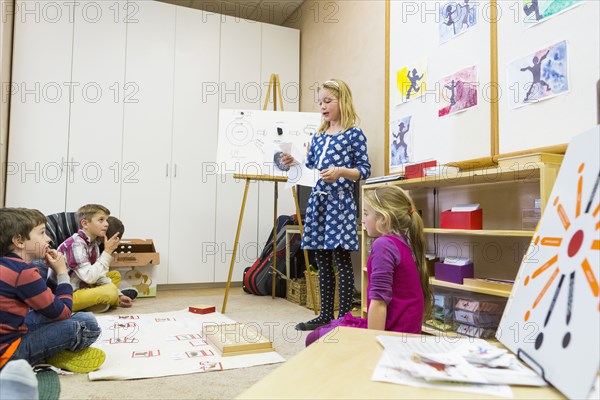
[221, 74, 317, 315]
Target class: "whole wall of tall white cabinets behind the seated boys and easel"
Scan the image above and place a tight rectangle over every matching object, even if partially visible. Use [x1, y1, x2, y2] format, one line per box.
[6, 0, 299, 284]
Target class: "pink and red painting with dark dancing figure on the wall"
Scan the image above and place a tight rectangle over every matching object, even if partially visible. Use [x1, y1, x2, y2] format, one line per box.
[438, 65, 478, 117]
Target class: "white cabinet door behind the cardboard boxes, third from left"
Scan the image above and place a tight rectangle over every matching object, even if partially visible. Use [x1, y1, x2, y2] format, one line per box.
[121, 1, 175, 283]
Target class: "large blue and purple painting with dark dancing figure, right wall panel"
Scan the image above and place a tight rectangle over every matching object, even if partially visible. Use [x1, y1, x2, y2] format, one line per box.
[508, 41, 569, 108]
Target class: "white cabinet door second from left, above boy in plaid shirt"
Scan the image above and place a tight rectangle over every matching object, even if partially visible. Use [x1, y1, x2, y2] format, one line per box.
[67, 0, 126, 216]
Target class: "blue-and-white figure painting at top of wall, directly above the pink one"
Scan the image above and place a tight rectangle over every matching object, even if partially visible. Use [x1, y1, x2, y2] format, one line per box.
[439, 0, 478, 43]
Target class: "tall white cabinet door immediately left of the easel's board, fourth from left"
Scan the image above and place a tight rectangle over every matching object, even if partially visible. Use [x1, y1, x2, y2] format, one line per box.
[168, 7, 220, 284]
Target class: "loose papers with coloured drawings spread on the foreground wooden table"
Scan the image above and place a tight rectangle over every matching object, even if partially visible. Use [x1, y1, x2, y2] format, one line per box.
[371, 335, 546, 398]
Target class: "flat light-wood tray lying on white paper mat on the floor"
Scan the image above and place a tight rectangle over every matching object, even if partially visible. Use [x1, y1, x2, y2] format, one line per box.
[202, 323, 274, 357]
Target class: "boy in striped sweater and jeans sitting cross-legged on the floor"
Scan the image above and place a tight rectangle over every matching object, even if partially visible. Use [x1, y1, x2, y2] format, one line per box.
[0, 208, 105, 373]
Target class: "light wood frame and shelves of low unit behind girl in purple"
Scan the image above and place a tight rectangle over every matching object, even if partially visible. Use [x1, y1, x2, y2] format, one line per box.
[361, 157, 560, 318]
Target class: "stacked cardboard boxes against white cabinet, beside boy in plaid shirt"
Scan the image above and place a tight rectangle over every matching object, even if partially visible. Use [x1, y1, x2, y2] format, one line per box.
[110, 239, 160, 297]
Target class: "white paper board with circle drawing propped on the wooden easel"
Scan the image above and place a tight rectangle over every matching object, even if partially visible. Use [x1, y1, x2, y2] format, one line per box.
[217, 109, 321, 176]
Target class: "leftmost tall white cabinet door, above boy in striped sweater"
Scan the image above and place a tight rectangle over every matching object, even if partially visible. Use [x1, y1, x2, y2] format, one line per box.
[6, 1, 73, 214]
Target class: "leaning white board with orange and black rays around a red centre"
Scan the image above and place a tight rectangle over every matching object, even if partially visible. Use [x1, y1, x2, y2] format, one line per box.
[496, 126, 600, 399]
